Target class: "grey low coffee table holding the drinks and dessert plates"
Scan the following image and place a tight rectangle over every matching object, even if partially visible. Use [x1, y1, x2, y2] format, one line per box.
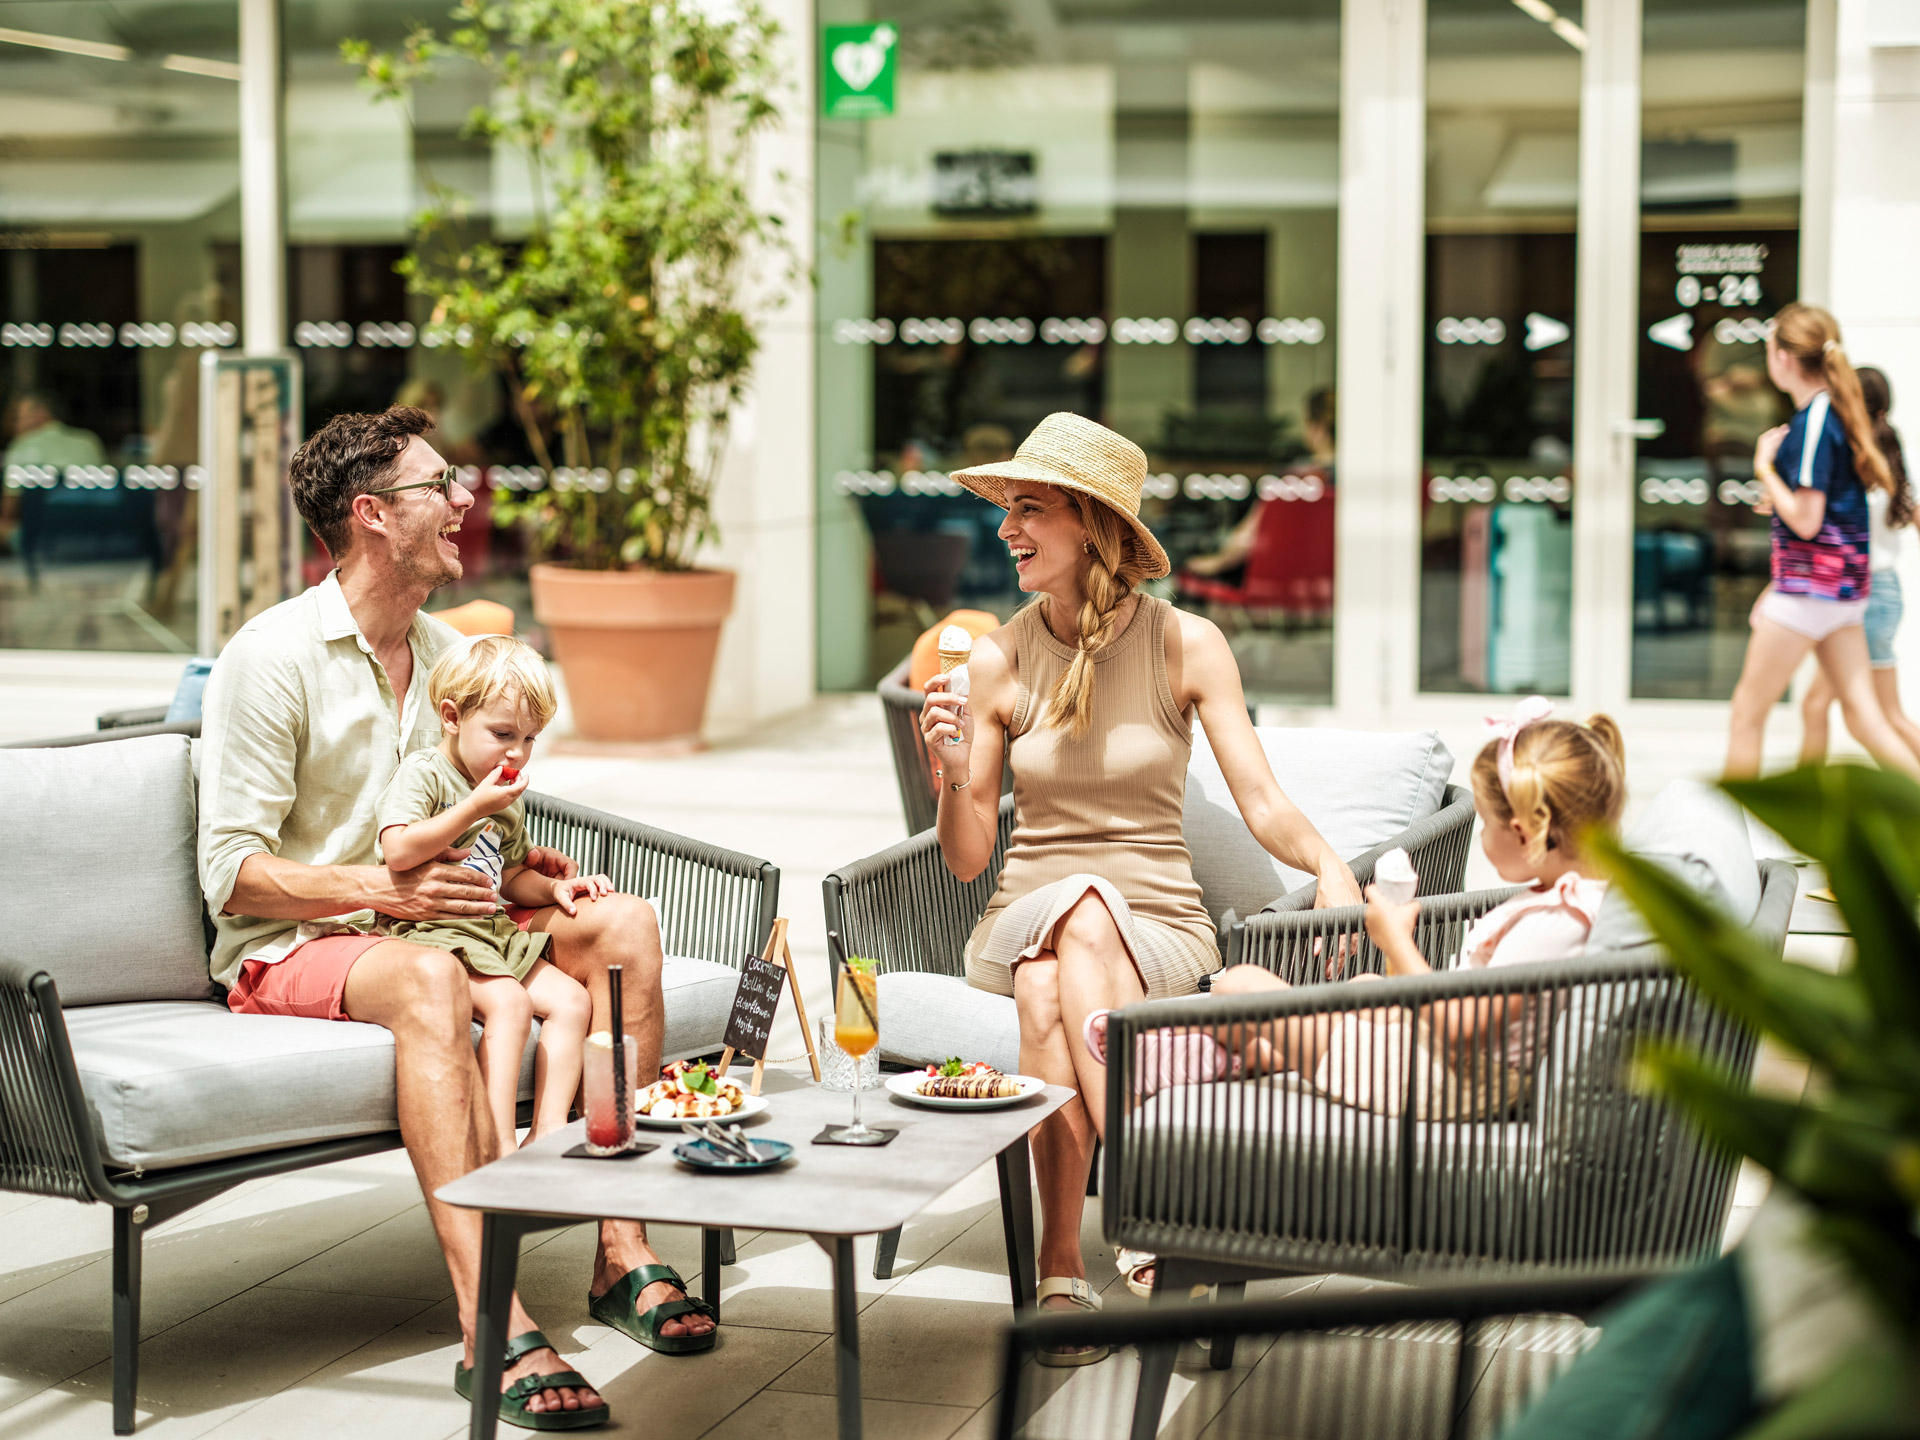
[438, 1069, 1073, 1440]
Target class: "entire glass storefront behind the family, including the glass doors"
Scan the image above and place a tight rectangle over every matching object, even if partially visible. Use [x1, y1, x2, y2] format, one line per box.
[0, 0, 1820, 721]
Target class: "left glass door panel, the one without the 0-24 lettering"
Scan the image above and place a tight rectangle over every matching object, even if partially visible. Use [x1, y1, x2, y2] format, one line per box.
[1419, 0, 1586, 695]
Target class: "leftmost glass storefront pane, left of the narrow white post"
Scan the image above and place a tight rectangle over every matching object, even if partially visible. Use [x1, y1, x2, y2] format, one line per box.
[0, 0, 240, 655]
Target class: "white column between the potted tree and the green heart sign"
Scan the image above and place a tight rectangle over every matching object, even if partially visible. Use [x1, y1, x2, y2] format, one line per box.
[703, 0, 818, 735]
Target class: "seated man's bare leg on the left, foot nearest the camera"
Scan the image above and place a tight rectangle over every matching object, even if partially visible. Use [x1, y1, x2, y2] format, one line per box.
[342, 941, 601, 1411]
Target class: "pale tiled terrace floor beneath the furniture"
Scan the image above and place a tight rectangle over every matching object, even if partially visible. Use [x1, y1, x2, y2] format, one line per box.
[0, 655, 1839, 1440]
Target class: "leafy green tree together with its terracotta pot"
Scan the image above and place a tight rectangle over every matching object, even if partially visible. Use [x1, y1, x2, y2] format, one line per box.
[342, 0, 787, 741]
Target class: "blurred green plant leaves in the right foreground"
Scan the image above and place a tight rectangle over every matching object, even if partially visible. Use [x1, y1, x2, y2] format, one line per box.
[1594, 766, 1920, 1374]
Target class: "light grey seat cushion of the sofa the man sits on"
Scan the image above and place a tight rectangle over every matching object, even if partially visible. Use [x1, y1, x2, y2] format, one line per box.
[65, 956, 739, 1169]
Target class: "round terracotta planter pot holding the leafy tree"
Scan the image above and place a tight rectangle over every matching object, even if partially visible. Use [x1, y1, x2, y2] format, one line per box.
[530, 564, 733, 741]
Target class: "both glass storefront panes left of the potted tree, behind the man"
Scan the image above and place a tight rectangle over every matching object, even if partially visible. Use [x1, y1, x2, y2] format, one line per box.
[0, 0, 556, 655]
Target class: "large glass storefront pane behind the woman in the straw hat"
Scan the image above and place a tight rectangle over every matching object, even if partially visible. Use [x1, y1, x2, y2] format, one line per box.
[818, 0, 1340, 703]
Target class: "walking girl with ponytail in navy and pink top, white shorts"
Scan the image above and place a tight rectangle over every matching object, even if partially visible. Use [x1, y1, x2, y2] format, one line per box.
[1726, 303, 1920, 780]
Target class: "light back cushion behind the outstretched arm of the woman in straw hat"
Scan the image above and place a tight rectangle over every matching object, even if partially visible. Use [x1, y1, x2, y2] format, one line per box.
[1185, 726, 1453, 925]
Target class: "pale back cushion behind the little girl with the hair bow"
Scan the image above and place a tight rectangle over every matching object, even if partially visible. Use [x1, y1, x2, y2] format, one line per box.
[1586, 780, 1761, 954]
